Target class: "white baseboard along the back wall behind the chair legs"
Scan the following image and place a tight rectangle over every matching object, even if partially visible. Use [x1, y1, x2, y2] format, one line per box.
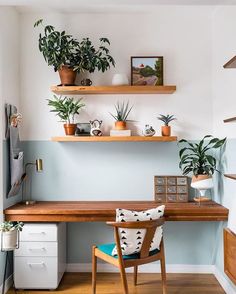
[66, 263, 215, 274]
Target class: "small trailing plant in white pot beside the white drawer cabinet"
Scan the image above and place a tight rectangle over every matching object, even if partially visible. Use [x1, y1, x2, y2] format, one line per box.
[0, 221, 24, 251]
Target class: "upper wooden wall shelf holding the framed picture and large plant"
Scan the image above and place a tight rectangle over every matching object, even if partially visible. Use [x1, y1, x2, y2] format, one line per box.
[51, 86, 176, 95]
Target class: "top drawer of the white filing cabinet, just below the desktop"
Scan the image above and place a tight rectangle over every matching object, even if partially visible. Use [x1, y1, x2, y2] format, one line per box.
[20, 224, 58, 241]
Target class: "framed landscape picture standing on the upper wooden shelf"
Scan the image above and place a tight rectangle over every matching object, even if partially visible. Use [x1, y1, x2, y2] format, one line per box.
[131, 56, 163, 86]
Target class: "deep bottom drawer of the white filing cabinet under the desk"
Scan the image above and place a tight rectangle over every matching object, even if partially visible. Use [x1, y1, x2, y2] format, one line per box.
[14, 257, 58, 289]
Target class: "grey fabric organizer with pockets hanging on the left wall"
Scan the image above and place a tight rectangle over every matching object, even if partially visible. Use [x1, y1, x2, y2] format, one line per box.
[5, 104, 24, 197]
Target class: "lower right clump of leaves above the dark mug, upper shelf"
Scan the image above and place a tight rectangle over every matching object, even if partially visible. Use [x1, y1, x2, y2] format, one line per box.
[75, 38, 115, 73]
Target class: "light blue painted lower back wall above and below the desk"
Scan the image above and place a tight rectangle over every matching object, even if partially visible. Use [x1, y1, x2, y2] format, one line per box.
[23, 141, 217, 265]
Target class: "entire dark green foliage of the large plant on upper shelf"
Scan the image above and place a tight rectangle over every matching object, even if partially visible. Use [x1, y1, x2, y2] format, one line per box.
[34, 19, 115, 73]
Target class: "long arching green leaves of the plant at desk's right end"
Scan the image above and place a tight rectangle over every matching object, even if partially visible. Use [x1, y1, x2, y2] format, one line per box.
[179, 135, 226, 175]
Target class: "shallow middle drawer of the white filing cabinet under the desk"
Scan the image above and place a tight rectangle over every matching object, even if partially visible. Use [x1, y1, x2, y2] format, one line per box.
[14, 242, 58, 256]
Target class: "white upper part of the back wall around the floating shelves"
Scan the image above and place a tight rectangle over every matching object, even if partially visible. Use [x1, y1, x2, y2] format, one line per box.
[21, 6, 212, 140]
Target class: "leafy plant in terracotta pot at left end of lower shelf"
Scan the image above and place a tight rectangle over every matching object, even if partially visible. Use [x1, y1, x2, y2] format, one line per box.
[47, 95, 85, 135]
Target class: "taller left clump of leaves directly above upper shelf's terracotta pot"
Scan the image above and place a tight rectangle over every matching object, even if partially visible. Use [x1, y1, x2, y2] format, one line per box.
[34, 19, 80, 71]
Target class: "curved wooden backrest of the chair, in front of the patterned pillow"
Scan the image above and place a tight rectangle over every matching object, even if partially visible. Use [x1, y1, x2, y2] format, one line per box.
[107, 217, 165, 258]
